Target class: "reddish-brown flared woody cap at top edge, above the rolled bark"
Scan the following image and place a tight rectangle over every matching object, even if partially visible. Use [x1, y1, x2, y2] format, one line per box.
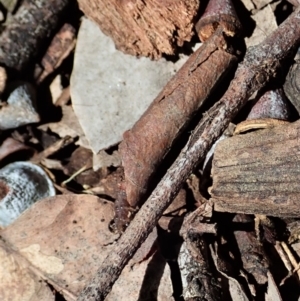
[196, 0, 242, 42]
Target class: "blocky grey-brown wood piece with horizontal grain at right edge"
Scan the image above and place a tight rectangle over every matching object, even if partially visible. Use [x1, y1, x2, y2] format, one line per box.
[210, 121, 300, 217]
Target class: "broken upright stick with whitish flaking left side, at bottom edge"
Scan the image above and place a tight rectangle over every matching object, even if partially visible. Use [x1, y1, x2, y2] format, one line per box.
[178, 203, 220, 301]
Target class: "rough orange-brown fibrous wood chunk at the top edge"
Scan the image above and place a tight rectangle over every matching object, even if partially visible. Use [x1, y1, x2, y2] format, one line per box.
[78, 0, 200, 59]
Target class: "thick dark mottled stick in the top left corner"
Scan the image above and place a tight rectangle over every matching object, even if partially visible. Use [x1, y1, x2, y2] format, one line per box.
[0, 0, 69, 70]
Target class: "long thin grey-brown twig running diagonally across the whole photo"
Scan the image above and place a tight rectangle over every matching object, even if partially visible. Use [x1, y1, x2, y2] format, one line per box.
[78, 8, 300, 301]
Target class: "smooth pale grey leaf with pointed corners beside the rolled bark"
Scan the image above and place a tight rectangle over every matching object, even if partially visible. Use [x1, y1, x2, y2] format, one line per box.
[71, 18, 185, 154]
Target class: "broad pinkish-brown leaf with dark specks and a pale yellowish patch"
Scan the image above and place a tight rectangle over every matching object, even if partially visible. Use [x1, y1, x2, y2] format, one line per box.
[1, 195, 118, 296]
